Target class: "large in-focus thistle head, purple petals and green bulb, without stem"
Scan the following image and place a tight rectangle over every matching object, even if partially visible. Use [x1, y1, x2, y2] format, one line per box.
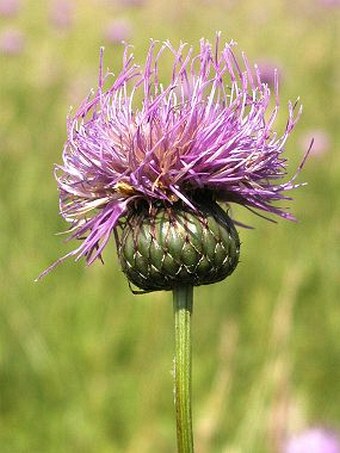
[42, 34, 303, 290]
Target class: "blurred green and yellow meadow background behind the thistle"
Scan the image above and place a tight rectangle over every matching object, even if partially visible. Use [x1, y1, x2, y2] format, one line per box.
[0, 0, 340, 453]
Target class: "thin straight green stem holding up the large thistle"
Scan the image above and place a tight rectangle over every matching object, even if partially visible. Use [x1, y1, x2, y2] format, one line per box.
[173, 285, 194, 453]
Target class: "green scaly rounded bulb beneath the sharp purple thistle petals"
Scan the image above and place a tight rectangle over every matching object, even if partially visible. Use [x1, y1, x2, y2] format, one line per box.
[117, 202, 240, 291]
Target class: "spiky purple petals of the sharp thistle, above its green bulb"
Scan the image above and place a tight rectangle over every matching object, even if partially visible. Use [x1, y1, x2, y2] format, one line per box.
[38, 35, 302, 276]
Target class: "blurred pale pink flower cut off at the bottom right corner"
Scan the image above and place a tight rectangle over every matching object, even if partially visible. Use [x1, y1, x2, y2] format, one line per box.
[284, 428, 340, 453]
